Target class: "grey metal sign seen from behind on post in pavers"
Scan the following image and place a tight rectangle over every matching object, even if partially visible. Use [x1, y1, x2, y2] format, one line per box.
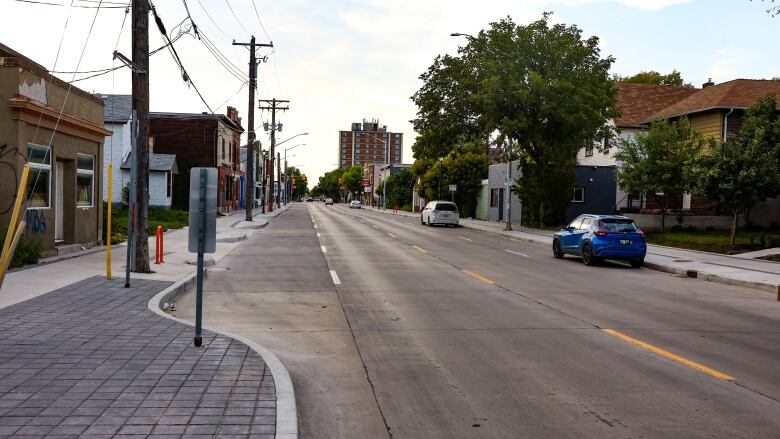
[188, 168, 217, 347]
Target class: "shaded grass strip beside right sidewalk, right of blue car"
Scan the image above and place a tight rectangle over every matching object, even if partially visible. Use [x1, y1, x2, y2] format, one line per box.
[646, 230, 780, 254]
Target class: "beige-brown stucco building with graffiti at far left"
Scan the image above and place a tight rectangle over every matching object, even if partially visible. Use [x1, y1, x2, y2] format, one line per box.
[0, 44, 110, 256]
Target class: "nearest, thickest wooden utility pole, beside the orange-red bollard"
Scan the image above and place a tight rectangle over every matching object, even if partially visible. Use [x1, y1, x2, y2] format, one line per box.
[131, 0, 151, 273]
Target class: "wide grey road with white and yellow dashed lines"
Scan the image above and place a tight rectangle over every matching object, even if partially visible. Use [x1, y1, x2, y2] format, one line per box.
[175, 203, 780, 438]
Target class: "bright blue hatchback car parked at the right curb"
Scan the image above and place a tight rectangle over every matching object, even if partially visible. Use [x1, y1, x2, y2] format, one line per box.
[553, 215, 647, 268]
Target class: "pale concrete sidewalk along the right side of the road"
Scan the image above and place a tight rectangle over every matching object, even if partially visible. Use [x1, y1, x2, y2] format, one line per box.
[367, 207, 780, 300]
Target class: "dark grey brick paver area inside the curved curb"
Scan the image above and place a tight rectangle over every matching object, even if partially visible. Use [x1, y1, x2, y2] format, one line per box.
[0, 277, 276, 438]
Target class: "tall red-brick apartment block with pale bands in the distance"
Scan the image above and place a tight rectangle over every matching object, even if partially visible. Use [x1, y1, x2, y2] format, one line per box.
[338, 119, 404, 168]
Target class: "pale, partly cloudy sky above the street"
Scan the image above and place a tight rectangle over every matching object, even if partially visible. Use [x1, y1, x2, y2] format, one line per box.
[0, 0, 780, 185]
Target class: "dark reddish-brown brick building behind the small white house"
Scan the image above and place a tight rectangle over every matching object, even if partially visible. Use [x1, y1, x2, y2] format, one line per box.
[149, 107, 244, 212]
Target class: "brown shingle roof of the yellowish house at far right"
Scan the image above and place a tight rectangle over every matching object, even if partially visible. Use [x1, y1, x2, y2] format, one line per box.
[645, 79, 780, 122]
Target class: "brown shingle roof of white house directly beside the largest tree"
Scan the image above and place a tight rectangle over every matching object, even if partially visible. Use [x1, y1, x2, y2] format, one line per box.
[615, 82, 699, 128]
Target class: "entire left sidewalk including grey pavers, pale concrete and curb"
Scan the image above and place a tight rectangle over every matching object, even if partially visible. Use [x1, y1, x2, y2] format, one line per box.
[0, 206, 297, 439]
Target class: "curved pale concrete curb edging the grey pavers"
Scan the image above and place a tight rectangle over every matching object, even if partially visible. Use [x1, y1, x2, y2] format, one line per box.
[147, 273, 298, 439]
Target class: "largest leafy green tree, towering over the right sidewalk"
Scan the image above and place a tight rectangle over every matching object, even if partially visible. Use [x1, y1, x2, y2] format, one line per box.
[412, 14, 618, 227]
